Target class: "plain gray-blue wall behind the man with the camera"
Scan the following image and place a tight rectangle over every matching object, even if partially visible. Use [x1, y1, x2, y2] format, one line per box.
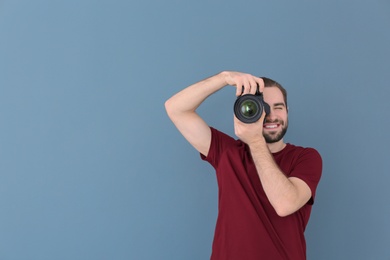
[0, 0, 390, 260]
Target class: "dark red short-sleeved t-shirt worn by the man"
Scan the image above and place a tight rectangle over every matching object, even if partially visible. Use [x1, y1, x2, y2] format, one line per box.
[201, 128, 322, 260]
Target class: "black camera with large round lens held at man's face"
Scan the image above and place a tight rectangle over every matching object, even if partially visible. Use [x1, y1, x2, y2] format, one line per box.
[234, 91, 270, 124]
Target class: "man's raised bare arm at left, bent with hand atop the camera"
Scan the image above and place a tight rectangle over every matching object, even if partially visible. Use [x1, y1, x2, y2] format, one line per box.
[165, 71, 264, 156]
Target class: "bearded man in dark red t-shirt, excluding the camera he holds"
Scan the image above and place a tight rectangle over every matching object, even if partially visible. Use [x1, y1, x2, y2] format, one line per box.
[165, 71, 322, 260]
